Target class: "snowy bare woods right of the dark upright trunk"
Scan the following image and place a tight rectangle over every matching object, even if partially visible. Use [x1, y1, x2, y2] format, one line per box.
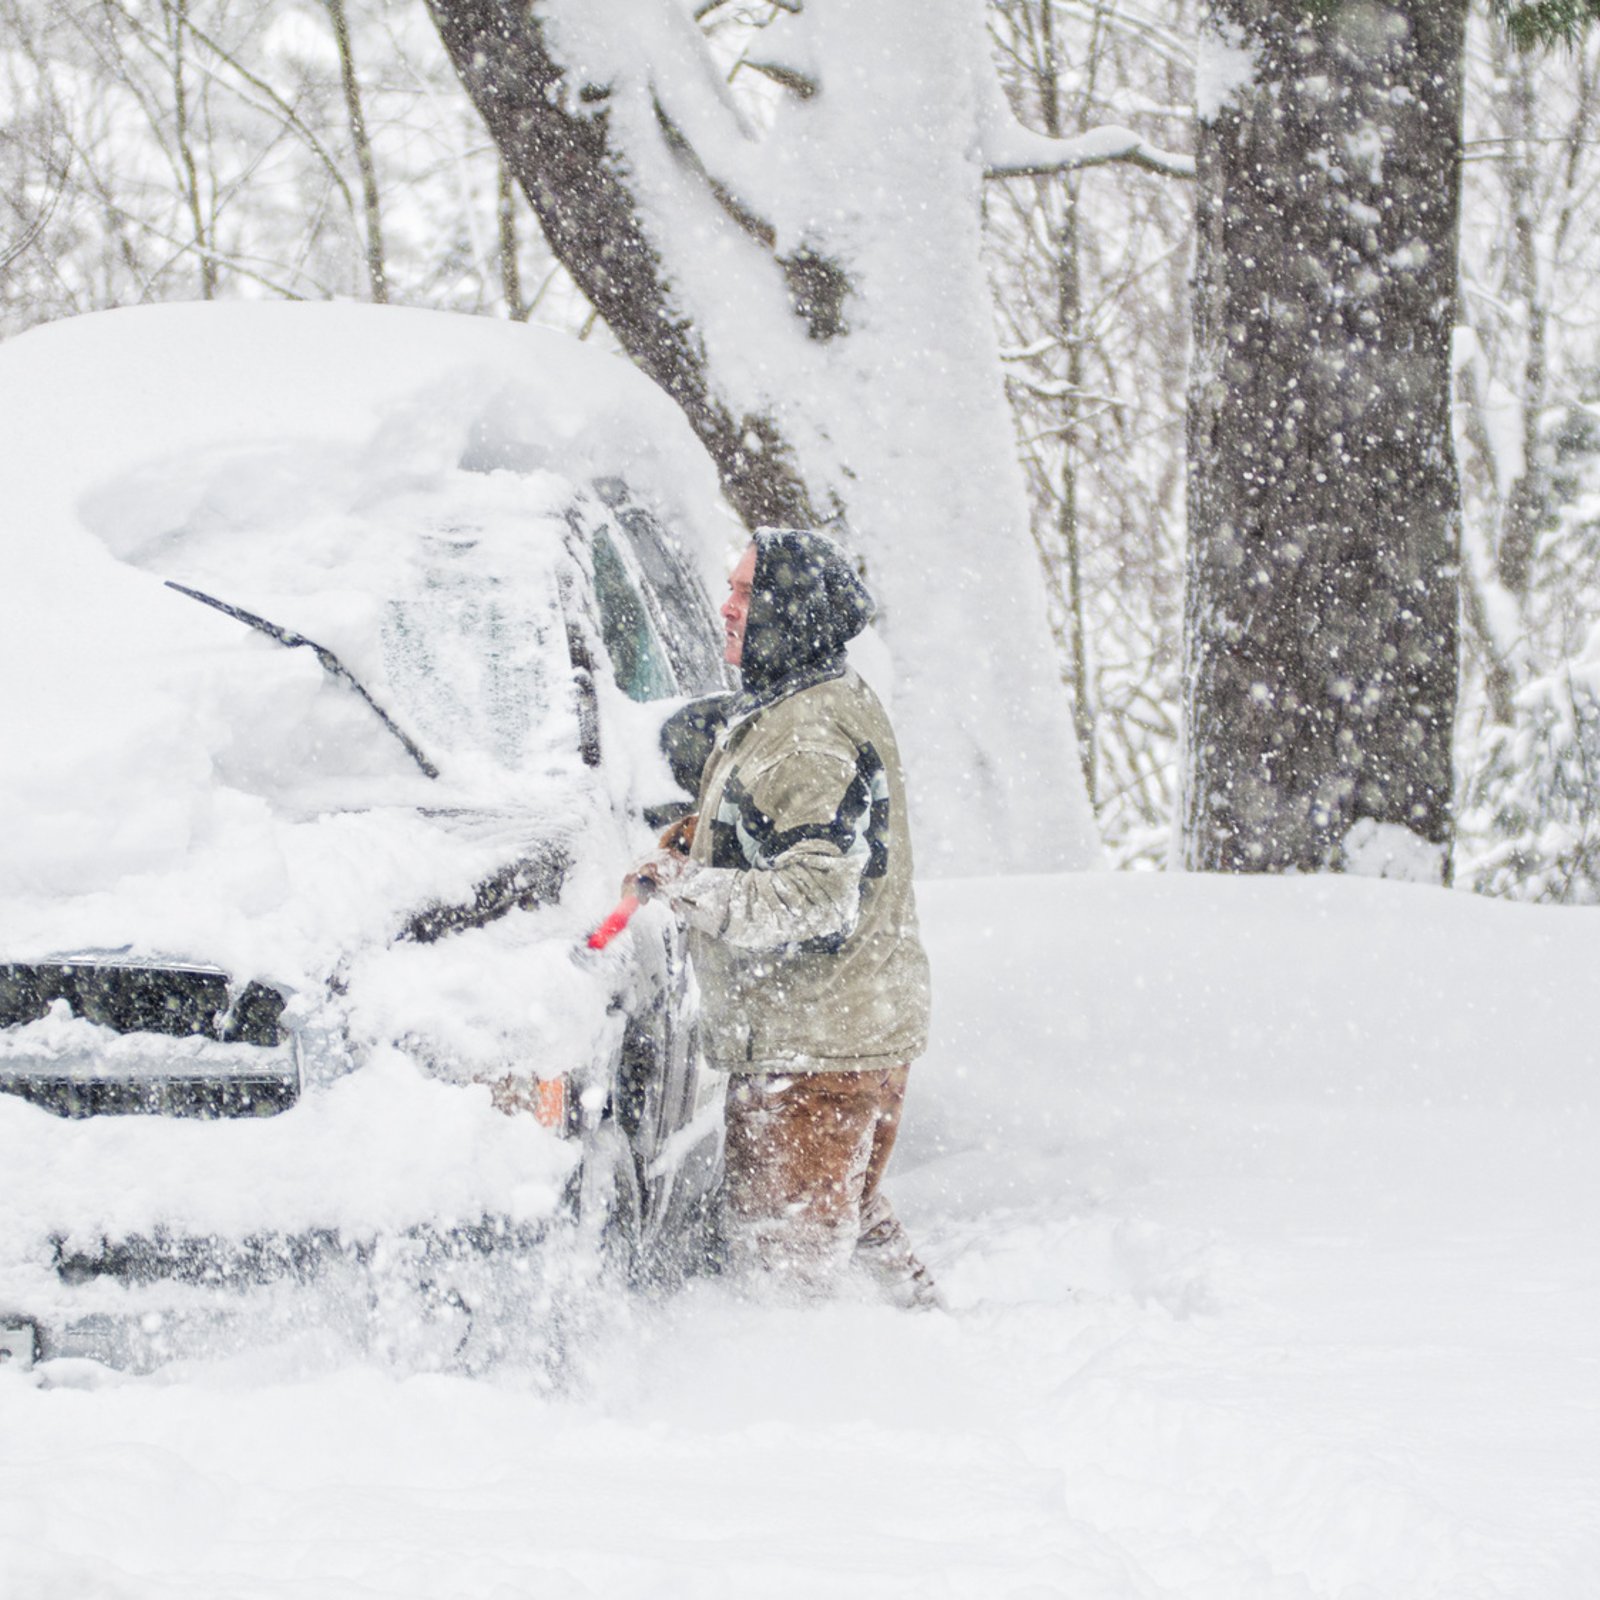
[1456, 9, 1600, 901]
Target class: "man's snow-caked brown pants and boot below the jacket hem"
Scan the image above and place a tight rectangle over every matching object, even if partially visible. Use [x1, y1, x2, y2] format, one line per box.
[725, 1067, 933, 1304]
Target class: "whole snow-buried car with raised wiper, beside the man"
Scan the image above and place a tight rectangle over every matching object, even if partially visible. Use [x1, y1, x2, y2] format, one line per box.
[0, 306, 723, 1365]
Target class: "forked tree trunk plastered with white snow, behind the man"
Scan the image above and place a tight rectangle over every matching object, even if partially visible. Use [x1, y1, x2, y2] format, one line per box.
[429, 0, 1098, 872]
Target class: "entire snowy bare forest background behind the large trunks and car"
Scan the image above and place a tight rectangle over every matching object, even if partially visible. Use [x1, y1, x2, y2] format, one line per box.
[0, 0, 1600, 902]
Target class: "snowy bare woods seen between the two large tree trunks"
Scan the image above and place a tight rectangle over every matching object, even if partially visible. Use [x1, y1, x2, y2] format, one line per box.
[987, 0, 1194, 864]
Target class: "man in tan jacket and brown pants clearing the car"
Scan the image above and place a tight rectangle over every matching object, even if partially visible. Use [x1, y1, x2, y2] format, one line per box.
[626, 528, 938, 1306]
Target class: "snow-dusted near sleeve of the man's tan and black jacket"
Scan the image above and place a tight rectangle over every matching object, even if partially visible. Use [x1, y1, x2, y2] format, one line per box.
[669, 747, 869, 950]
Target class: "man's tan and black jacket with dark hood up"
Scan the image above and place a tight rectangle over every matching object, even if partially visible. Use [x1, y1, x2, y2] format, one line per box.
[672, 528, 928, 1072]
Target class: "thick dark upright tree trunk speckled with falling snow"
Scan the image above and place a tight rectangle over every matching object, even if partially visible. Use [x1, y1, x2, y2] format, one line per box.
[1182, 0, 1466, 882]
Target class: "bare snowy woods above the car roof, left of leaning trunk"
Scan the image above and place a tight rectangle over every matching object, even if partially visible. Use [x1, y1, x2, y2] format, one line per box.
[0, 0, 576, 334]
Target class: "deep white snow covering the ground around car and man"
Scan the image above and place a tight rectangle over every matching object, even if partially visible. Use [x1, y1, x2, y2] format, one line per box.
[0, 875, 1600, 1600]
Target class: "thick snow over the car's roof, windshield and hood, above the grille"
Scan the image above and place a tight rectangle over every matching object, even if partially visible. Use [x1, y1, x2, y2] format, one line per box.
[0, 304, 728, 986]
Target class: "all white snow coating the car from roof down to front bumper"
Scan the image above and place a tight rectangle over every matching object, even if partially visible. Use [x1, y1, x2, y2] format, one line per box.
[0, 304, 725, 1259]
